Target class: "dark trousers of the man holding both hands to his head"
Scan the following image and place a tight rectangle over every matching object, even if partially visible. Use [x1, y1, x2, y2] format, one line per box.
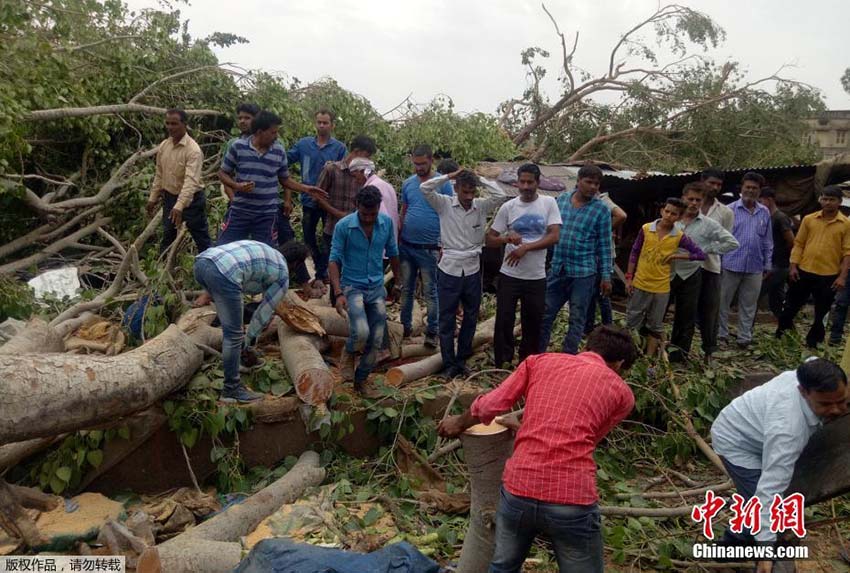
[437, 268, 481, 368]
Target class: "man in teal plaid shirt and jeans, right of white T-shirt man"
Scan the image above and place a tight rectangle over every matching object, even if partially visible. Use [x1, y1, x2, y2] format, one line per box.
[539, 165, 613, 354]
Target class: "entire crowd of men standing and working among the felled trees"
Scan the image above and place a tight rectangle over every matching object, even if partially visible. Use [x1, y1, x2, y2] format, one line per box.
[147, 104, 850, 572]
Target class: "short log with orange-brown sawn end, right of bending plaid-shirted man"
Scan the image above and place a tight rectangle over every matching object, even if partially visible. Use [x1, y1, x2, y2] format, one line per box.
[277, 323, 334, 406]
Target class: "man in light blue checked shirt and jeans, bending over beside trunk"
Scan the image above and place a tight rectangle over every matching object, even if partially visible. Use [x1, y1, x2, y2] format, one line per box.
[195, 241, 307, 402]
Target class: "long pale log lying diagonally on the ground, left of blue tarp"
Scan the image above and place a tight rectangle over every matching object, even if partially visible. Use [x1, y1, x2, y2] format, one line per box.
[136, 451, 325, 573]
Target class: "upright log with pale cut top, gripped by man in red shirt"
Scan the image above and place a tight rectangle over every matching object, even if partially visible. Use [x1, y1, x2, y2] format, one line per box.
[457, 422, 514, 573]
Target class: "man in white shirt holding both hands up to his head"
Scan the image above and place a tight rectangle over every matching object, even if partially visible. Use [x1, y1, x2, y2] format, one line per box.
[419, 169, 507, 378]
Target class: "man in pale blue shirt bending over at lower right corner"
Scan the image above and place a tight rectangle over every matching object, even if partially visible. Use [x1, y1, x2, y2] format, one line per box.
[711, 358, 848, 571]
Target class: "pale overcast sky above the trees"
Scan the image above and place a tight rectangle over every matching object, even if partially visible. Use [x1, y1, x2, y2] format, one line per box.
[128, 0, 850, 113]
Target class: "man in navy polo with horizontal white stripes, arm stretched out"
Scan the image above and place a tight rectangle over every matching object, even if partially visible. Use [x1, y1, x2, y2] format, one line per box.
[217, 111, 327, 246]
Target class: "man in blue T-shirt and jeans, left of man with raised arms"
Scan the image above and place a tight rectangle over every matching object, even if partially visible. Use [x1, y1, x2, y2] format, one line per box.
[395, 145, 453, 348]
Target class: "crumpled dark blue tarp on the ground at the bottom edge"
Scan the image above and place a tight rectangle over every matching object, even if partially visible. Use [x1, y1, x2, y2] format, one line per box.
[234, 537, 440, 573]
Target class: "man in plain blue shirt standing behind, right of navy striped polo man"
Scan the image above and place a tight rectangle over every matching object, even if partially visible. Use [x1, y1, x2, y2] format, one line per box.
[284, 108, 347, 281]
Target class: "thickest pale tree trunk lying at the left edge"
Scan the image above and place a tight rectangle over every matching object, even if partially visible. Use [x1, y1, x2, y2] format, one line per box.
[0, 325, 203, 444]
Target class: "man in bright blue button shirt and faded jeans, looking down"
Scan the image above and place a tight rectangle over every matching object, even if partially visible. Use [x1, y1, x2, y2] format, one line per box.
[328, 185, 399, 393]
